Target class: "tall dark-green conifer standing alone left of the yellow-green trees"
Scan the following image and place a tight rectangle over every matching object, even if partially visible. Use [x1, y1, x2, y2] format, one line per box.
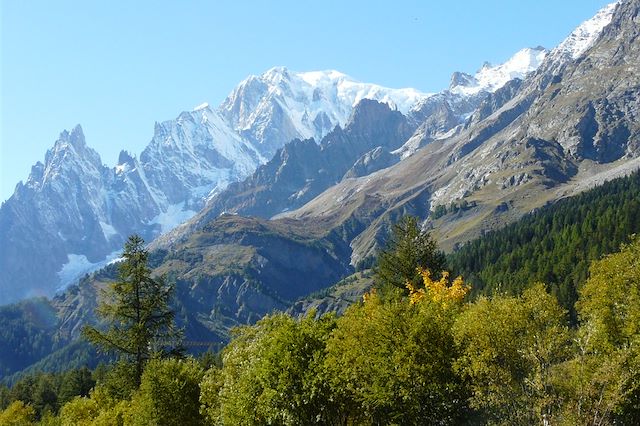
[83, 235, 181, 386]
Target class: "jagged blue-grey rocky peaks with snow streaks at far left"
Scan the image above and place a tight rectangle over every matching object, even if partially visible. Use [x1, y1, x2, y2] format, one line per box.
[0, 107, 264, 303]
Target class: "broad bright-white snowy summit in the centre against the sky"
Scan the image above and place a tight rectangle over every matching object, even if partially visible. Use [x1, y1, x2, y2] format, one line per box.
[219, 67, 428, 158]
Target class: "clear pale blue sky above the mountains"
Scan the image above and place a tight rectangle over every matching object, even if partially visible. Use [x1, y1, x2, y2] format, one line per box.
[0, 0, 608, 200]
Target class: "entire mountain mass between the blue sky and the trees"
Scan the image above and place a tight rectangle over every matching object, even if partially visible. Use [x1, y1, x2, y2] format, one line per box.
[0, 0, 640, 390]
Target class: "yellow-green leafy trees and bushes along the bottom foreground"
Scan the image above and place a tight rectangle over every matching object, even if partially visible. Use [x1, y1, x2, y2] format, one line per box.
[0, 238, 640, 425]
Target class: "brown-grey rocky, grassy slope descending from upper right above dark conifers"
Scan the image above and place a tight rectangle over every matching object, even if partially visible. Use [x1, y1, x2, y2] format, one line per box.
[286, 0, 640, 263]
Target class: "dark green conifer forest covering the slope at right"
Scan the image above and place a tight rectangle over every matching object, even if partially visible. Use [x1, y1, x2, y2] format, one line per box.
[448, 173, 640, 323]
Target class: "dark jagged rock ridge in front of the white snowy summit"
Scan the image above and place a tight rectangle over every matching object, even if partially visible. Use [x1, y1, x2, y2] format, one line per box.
[200, 100, 413, 220]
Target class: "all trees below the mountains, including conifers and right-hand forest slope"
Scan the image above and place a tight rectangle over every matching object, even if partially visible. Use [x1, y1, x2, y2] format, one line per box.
[0, 173, 640, 425]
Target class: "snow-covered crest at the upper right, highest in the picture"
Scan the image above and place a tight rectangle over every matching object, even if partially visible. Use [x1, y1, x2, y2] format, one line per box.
[550, 0, 620, 59]
